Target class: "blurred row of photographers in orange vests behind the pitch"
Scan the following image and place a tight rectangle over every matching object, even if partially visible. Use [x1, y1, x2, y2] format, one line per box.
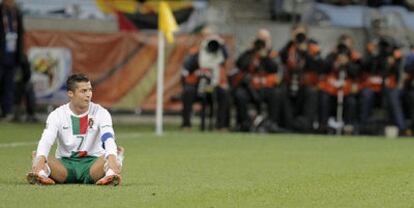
[181, 24, 414, 136]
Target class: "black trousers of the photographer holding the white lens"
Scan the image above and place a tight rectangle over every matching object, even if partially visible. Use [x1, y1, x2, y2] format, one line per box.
[181, 84, 230, 129]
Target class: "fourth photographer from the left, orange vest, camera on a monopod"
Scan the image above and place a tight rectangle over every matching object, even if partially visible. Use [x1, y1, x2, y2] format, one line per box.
[319, 34, 361, 134]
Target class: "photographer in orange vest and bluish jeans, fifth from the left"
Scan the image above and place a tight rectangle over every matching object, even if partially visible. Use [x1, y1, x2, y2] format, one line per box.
[360, 36, 406, 132]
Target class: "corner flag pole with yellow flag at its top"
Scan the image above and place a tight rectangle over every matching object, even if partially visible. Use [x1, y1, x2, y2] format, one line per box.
[155, 1, 178, 135]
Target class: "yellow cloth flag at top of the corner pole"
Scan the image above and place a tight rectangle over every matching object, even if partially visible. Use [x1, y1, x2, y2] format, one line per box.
[158, 1, 178, 43]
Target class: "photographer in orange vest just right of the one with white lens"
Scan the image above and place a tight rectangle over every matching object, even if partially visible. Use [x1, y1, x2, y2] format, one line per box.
[231, 29, 281, 132]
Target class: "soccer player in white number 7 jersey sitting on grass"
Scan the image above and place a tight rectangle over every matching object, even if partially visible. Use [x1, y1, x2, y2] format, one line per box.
[27, 74, 123, 186]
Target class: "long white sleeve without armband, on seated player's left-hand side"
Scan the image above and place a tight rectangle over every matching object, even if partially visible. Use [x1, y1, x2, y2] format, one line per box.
[36, 111, 59, 158]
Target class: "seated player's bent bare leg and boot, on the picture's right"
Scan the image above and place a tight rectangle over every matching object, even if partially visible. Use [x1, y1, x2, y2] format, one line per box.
[94, 147, 124, 186]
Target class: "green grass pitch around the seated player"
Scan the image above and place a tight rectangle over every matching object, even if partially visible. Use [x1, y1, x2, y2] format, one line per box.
[0, 123, 414, 208]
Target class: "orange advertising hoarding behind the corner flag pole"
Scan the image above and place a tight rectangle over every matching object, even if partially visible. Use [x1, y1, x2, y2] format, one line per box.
[25, 31, 234, 112]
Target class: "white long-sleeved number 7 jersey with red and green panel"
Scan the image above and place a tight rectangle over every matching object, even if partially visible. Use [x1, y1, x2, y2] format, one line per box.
[36, 102, 115, 158]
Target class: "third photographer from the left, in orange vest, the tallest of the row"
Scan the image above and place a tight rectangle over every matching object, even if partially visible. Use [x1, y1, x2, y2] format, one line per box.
[280, 25, 323, 132]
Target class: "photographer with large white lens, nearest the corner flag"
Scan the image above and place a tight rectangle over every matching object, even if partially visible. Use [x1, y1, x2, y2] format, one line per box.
[181, 35, 230, 130]
